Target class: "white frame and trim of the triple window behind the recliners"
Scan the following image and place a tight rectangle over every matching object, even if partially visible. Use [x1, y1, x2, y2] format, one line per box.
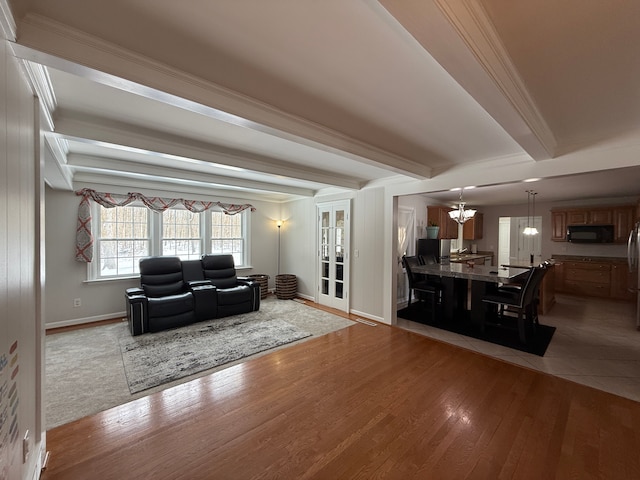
[87, 203, 251, 282]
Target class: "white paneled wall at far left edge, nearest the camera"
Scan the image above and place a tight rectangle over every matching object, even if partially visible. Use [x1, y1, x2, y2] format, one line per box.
[0, 36, 45, 479]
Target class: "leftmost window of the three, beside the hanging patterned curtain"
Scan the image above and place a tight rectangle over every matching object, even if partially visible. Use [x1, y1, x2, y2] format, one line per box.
[94, 207, 149, 277]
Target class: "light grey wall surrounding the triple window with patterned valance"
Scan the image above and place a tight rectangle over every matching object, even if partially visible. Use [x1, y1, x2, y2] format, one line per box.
[45, 186, 282, 328]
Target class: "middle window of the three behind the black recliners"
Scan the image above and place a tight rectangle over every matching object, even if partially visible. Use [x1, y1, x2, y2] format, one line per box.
[162, 208, 202, 260]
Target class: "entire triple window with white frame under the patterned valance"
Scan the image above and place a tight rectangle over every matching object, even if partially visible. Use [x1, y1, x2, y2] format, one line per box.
[89, 204, 249, 280]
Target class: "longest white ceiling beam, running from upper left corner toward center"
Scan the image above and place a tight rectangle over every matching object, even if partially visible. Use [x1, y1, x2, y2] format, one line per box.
[16, 14, 432, 179]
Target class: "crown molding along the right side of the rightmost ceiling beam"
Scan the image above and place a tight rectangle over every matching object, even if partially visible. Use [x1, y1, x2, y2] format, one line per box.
[435, 0, 557, 157]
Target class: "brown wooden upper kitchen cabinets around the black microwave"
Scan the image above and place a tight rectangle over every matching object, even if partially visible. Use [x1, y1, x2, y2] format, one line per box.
[551, 205, 636, 243]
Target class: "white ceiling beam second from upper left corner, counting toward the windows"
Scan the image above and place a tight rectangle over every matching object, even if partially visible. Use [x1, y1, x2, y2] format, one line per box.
[55, 115, 362, 190]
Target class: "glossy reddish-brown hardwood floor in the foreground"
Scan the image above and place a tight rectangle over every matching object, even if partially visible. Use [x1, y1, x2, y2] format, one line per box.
[42, 302, 640, 480]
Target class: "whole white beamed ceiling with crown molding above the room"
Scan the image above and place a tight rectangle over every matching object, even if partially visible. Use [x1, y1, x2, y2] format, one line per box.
[1, 0, 640, 205]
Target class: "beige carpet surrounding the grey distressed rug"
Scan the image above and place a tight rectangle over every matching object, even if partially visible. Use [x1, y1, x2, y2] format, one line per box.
[45, 296, 354, 429]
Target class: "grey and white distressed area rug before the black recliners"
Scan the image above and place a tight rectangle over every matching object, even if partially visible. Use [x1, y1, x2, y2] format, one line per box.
[120, 311, 311, 393]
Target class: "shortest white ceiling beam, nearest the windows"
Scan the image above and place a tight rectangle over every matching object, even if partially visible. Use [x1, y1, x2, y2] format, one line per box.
[67, 153, 316, 197]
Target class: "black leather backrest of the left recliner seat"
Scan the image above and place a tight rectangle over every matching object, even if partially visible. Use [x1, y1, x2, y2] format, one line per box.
[140, 257, 184, 297]
